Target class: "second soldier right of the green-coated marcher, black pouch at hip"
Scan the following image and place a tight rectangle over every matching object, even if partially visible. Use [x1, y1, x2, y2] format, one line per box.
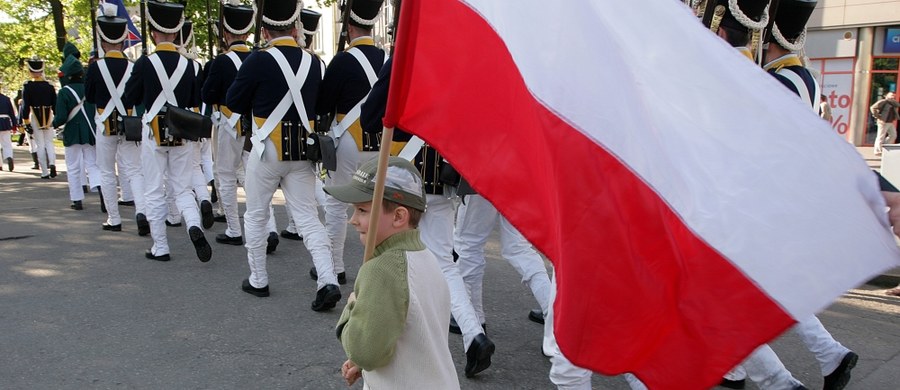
[125, 0, 212, 262]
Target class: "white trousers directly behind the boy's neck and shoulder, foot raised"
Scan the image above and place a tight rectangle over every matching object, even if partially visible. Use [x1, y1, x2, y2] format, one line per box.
[419, 194, 484, 350]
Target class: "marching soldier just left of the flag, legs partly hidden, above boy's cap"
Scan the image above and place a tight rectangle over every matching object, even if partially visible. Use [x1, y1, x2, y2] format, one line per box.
[314, 0, 385, 284]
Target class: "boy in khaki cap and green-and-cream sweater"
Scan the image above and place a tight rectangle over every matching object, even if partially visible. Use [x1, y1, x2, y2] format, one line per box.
[325, 157, 459, 389]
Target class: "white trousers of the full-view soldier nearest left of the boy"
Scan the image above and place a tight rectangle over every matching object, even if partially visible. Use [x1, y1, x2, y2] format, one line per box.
[244, 139, 337, 289]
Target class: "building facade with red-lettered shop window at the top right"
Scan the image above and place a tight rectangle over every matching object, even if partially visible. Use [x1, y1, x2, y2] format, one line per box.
[804, 0, 900, 146]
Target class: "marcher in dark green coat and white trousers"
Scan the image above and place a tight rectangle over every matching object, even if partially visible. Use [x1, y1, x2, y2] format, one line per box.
[52, 55, 100, 210]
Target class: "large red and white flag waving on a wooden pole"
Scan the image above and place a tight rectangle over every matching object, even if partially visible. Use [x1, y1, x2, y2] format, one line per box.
[384, 0, 900, 389]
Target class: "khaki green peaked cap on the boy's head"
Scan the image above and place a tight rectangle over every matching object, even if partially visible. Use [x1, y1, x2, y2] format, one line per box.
[325, 157, 425, 211]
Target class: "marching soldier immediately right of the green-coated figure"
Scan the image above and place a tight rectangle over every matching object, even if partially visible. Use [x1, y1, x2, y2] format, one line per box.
[85, 4, 150, 236]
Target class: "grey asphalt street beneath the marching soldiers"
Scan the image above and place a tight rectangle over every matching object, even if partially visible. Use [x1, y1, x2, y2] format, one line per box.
[0, 147, 900, 390]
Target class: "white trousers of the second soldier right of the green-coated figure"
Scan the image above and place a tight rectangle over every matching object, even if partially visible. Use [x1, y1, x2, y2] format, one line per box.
[141, 142, 201, 256]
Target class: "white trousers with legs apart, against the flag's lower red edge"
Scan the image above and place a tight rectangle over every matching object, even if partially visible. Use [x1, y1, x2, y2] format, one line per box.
[453, 194, 550, 323]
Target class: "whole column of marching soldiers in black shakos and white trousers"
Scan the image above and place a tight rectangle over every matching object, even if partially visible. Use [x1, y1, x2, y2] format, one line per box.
[0, 0, 888, 389]
